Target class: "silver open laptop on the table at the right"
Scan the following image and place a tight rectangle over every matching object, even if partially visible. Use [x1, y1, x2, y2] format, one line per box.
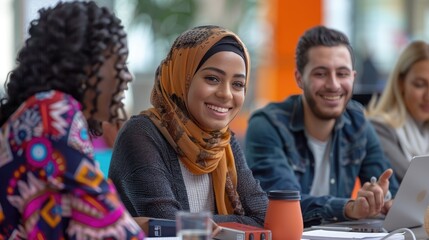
[322, 155, 429, 232]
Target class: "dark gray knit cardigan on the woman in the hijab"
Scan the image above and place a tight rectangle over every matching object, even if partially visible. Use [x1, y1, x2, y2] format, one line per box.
[109, 115, 268, 227]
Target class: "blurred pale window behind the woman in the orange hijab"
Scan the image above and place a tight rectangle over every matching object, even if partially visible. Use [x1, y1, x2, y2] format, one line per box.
[115, 0, 260, 114]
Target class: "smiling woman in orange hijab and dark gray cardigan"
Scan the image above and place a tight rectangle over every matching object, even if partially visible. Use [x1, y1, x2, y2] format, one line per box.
[109, 26, 268, 226]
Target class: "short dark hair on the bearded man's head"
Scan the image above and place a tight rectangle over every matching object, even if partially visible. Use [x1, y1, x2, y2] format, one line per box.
[295, 26, 354, 73]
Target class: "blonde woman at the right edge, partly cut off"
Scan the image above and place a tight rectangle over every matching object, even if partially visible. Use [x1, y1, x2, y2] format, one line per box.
[367, 41, 429, 181]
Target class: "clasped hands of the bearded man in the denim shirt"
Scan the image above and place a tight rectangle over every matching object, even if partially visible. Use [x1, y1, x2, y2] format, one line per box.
[345, 169, 393, 219]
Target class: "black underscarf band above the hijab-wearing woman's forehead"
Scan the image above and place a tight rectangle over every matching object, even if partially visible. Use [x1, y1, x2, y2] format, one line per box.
[195, 37, 247, 72]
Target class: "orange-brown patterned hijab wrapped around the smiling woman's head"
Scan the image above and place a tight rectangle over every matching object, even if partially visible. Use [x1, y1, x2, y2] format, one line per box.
[142, 26, 250, 215]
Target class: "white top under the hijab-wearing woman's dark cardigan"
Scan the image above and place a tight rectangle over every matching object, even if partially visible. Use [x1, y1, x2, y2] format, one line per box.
[179, 161, 215, 212]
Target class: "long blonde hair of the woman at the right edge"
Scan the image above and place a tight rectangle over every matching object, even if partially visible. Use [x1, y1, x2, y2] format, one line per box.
[366, 41, 429, 128]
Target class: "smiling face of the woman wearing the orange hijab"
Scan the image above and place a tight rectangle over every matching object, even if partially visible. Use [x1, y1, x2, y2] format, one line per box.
[187, 51, 246, 131]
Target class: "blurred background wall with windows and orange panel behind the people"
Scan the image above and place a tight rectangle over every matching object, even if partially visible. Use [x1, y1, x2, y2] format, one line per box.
[0, 0, 429, 142]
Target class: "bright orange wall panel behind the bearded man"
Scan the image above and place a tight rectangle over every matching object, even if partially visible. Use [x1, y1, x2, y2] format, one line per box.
[257, 0, 323, 102]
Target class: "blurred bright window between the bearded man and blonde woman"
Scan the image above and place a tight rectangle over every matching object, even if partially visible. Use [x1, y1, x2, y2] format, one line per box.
[352, 0, 429, 94]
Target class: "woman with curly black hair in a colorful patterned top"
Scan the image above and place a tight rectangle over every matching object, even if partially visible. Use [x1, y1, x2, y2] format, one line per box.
[0, 1, 144, 239]
